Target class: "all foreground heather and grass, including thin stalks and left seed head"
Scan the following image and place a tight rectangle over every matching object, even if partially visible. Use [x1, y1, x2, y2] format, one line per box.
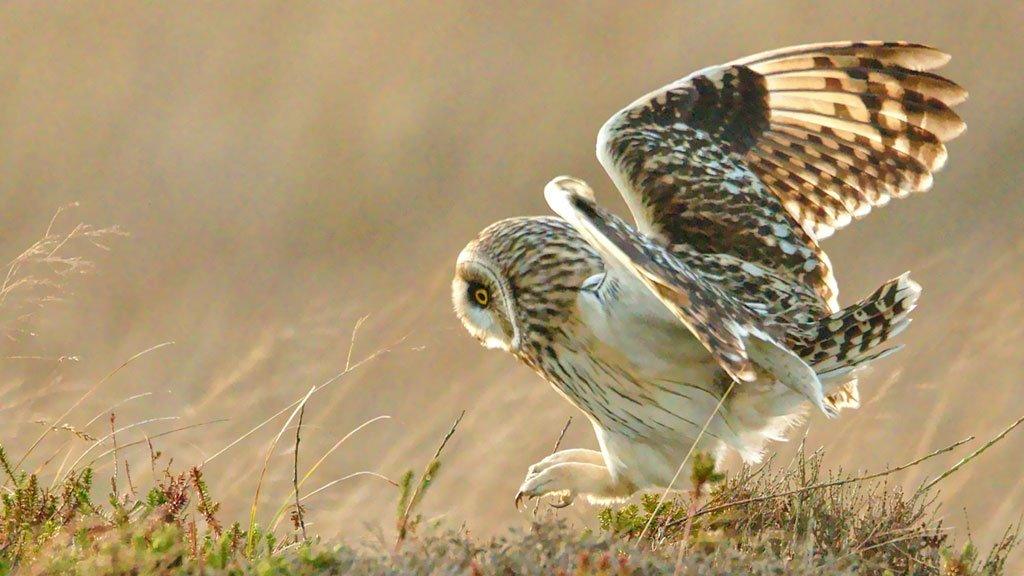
[0, 207, 1022, 576]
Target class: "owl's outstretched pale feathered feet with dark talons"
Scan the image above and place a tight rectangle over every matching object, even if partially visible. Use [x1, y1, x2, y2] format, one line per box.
[515, 462, 636, 508]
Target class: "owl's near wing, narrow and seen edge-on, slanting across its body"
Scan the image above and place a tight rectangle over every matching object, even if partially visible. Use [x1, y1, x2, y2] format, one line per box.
[544, 176, 836, 416]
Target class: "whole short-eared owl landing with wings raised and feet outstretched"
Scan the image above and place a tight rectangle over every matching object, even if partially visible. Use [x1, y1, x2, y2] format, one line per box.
[453, 42, 967, 505]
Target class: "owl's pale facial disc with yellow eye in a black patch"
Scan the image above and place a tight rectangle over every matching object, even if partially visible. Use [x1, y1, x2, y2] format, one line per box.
[452, 242, 519, 352]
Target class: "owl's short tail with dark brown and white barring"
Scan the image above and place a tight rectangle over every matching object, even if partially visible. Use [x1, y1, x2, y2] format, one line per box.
[791, 273, 921, 383]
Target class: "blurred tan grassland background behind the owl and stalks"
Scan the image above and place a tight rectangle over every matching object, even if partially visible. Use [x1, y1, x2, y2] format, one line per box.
[0, 0, 1024, 561]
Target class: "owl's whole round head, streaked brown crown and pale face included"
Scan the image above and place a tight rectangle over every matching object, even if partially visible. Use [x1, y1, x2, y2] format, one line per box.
[452, 216, 601, 356]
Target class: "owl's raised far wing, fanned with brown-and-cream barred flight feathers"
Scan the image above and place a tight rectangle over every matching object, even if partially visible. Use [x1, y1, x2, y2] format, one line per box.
[597, 42, 967, 308]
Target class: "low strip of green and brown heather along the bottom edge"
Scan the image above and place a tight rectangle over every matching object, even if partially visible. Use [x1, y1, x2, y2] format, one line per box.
[0, 430, 1018, 576]
